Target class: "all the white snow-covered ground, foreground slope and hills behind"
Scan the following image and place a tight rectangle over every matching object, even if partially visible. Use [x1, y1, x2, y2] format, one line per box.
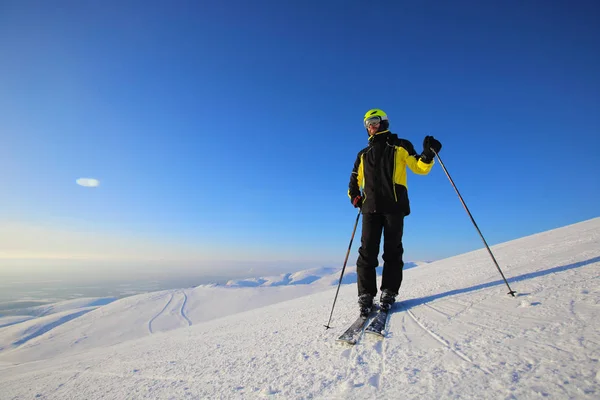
[0, 218, 600, 399]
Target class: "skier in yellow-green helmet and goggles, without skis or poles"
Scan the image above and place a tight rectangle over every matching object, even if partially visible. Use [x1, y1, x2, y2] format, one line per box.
[348, 109, 442, 315]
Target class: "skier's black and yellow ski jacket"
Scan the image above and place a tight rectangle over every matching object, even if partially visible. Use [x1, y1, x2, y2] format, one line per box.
[348, 131, 434, 215]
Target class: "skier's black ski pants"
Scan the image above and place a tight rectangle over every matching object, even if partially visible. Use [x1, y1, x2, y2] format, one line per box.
[356, 213, 404, 297]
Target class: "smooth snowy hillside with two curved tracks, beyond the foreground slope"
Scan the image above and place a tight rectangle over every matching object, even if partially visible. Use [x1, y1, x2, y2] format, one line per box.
[0, 282, 339, 363]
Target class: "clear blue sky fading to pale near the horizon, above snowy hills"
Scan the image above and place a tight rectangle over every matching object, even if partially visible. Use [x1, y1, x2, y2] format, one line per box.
[0, 1, 600, 276]
